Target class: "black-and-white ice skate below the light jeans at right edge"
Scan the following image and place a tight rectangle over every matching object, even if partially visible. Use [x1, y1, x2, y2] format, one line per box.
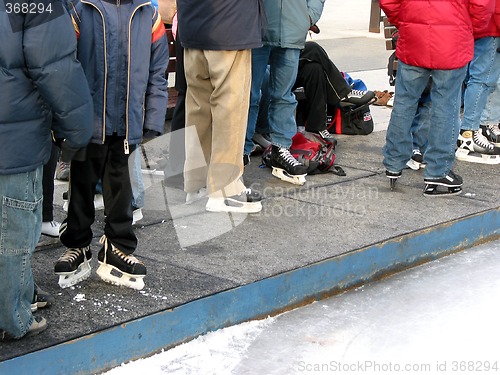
[455, 130, 500, 164]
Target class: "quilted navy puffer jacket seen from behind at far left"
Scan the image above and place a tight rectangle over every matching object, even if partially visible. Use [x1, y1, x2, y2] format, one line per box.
[0, 1, 92, 175]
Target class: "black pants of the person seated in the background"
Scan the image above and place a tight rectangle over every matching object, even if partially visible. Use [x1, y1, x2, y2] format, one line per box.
[294, 42, 351, 132]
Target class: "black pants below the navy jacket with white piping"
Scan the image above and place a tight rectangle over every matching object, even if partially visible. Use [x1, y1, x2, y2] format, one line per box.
[60, 135, 137, 255]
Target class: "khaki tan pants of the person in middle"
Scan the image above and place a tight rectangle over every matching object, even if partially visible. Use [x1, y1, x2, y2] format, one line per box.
[184, 49, 251, 196]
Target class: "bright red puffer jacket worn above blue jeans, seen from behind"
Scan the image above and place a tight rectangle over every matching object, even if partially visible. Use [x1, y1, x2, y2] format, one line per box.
[380, 0, 497, 69]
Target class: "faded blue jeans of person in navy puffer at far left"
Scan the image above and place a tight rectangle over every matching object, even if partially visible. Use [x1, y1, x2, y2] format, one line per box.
[0, 166, 43, 338]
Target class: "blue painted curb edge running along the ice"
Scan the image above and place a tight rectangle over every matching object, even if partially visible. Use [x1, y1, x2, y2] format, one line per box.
[0, 208, 500, 375]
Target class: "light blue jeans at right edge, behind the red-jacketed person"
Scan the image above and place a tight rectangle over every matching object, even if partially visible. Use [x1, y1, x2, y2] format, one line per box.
[462, 37, 500, 130]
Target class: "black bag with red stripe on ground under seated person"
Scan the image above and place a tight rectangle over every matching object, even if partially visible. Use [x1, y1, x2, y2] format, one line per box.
[326, 101, 374, 135]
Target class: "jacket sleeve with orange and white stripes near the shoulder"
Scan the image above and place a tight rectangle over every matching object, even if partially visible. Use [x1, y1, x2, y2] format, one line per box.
[144, 9, 169, 134]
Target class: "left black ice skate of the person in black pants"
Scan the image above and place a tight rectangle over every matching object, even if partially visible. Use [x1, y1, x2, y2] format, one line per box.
[54, 246, 92, 288]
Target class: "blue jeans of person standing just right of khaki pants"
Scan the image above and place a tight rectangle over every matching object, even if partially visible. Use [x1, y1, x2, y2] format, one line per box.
[244, 46, 300, 154]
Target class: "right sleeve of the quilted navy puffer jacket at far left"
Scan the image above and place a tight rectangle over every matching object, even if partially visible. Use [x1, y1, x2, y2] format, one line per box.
[23, 2, 93, 148]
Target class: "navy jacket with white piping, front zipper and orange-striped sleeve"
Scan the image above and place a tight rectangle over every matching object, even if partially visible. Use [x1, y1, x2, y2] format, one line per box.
[70, 0, 169, 149]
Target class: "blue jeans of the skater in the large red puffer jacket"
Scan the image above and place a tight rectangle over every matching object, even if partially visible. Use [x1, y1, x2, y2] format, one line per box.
[383, 61, 467, 178]
